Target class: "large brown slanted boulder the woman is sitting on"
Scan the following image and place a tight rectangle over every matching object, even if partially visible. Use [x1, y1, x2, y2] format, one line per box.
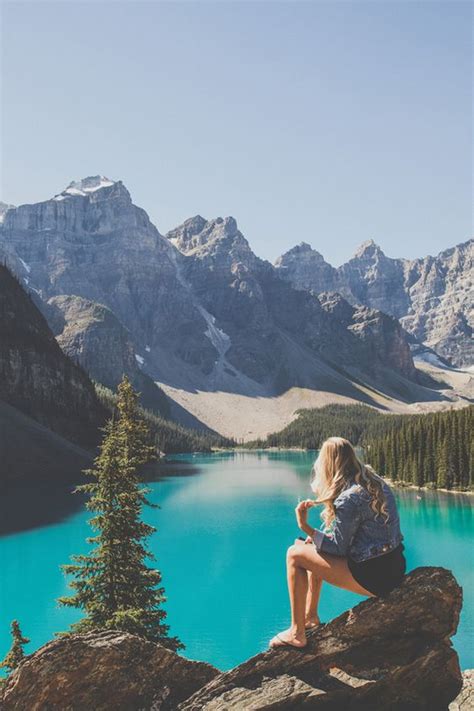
[179, 568, 462, 711]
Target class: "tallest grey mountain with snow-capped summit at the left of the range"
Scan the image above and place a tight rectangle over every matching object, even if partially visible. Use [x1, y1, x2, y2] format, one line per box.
[0, 181, 216, 386]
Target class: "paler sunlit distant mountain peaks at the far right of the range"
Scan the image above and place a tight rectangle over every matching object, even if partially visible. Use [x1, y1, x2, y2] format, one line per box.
[275, 240, 474, 366]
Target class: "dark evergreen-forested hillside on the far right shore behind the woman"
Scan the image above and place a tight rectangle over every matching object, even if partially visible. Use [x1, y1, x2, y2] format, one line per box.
[251, 405, 474, 489]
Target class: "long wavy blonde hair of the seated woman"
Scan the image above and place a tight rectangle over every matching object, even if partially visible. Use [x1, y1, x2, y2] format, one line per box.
[311, 437, 389, 528]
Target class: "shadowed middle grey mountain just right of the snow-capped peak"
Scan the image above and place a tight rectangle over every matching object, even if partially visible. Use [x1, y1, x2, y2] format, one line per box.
[167, 216, 415, 388]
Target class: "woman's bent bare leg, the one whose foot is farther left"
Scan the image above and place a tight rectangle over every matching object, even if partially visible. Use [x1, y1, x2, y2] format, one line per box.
[270, 544, 372, 647]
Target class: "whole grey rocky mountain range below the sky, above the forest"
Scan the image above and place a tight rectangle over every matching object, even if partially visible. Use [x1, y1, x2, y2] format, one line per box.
[0, 176, 472, 438]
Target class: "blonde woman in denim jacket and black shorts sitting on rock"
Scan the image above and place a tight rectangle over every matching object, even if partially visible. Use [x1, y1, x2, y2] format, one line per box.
[270, 437, 406, 647]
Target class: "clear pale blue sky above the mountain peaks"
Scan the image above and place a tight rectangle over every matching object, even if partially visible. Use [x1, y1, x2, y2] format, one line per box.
[1, 0, 472, 264]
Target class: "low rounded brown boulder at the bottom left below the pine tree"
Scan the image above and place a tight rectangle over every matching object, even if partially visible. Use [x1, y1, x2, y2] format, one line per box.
[1, 631, 218, 711]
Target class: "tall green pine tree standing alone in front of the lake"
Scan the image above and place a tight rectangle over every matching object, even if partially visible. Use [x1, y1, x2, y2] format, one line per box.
[59, 378, 183, 649]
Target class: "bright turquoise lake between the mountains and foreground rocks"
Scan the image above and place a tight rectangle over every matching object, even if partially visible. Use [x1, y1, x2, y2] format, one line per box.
[0, 452, 474, 669]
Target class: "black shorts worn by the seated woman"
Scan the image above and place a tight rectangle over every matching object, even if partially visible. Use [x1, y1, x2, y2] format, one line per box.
[347, 543, 406, 596]
